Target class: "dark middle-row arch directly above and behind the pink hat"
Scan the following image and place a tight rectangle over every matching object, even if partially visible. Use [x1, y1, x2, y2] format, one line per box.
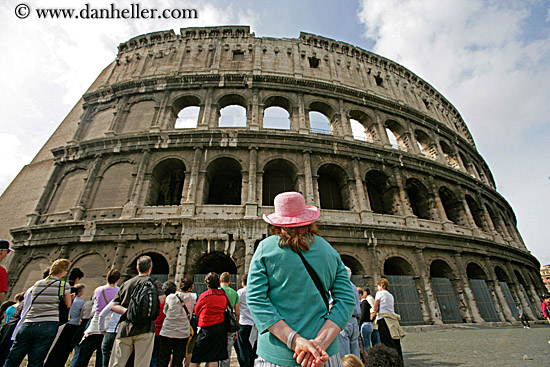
[262, 158, 298, 206]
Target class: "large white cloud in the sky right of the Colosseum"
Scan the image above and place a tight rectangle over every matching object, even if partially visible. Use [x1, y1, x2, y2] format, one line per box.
[359, 0, 550, 261]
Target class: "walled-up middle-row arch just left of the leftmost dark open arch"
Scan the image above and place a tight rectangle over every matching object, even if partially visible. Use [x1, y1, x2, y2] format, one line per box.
[90, 158, 138, 208]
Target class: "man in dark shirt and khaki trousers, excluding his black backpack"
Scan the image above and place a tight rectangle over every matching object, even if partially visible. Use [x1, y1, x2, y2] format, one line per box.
[109, 256, 166, 367]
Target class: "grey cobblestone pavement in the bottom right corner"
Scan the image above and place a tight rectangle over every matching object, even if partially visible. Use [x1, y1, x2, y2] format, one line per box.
[402, 324, 550, 367]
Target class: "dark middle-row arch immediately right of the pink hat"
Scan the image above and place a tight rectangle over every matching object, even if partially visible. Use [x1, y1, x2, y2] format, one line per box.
[317, 163, 350, 210]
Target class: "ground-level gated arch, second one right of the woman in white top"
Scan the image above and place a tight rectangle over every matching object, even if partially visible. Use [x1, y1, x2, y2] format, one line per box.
[430, 258, 468, 323]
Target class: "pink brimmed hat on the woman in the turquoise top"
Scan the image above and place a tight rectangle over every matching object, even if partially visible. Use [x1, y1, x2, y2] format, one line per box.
[264, 192, 321, 227]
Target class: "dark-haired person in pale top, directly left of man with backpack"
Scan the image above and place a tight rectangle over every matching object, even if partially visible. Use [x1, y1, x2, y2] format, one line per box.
[76, 269, 120, 367]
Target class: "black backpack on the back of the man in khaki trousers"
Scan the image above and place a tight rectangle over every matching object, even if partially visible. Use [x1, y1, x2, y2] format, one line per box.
[126, 277, 160, 324]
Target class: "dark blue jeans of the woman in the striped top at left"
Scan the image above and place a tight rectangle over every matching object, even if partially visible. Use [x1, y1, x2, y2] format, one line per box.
[4, 321, 59, 367]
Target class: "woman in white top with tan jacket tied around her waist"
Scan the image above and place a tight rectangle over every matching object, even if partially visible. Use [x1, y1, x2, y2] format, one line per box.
[374, 278, 405, 360]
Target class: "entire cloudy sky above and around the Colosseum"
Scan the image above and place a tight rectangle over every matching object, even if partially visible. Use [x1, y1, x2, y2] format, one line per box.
[0, 0, 550, 265]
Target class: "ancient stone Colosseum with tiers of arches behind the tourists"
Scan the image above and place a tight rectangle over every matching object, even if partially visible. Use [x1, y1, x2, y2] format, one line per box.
[0, 26, 543, 325]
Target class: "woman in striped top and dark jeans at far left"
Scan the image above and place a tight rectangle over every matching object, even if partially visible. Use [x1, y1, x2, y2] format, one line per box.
[4, 259, 71, 367]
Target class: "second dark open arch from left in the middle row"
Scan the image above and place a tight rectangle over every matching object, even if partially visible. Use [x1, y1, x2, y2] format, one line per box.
[203, 154, 243, 205]
